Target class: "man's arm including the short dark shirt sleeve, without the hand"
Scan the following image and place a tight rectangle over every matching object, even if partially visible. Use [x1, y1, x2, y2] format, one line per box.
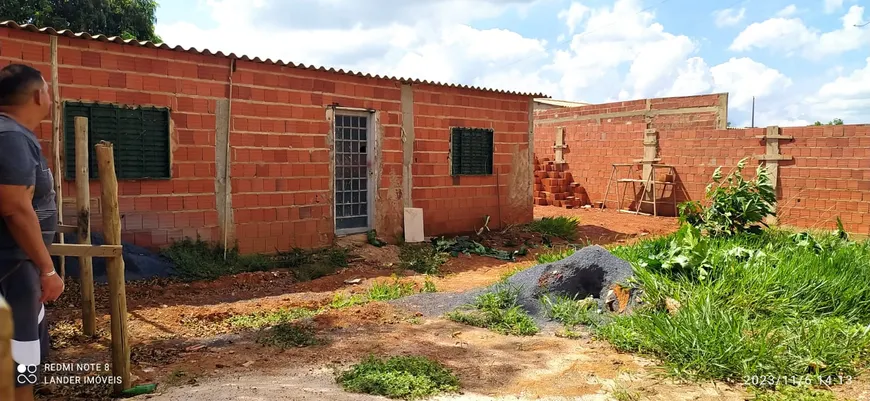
[0, 132, 54, 274]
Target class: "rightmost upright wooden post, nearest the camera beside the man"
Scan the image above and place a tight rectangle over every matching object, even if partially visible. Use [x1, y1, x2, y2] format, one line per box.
[96, 141, 131, 392]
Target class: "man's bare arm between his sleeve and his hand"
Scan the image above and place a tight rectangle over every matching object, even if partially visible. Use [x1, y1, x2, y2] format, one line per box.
[0, 185, 54, 274]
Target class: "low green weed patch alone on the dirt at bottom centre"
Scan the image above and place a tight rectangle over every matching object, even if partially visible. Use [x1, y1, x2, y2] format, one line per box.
[336, 356, 459, 400]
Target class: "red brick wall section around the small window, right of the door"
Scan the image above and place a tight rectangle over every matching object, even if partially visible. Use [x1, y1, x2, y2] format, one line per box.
[413, 86, 533, 235]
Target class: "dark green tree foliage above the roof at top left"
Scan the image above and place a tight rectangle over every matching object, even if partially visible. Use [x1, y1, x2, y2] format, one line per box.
[0, 0, 162, 42]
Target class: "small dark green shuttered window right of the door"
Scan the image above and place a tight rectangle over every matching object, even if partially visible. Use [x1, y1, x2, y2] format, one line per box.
[450, 127, 493, 175]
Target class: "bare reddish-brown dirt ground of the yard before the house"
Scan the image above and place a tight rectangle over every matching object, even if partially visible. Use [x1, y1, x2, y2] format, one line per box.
[39, 207, 866, 401]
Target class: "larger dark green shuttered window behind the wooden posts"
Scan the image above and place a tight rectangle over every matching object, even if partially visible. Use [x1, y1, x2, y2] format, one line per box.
[63, 102, 172, 180]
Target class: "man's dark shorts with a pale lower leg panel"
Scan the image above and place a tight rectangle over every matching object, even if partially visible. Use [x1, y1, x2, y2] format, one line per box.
[0, 260, 49, 387]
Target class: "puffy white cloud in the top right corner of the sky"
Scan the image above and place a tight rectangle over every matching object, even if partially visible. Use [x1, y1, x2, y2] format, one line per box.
[729, 5, 870, 60]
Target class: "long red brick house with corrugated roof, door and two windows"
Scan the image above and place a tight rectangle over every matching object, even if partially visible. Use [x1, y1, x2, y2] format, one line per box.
[0, 22, 542, 252]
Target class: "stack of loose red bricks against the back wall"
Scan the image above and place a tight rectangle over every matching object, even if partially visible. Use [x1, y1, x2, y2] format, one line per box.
[535, 157, 588, 209]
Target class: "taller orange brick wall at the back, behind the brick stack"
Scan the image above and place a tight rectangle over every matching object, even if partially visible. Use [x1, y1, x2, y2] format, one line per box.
[535, 94, 727, 202]
